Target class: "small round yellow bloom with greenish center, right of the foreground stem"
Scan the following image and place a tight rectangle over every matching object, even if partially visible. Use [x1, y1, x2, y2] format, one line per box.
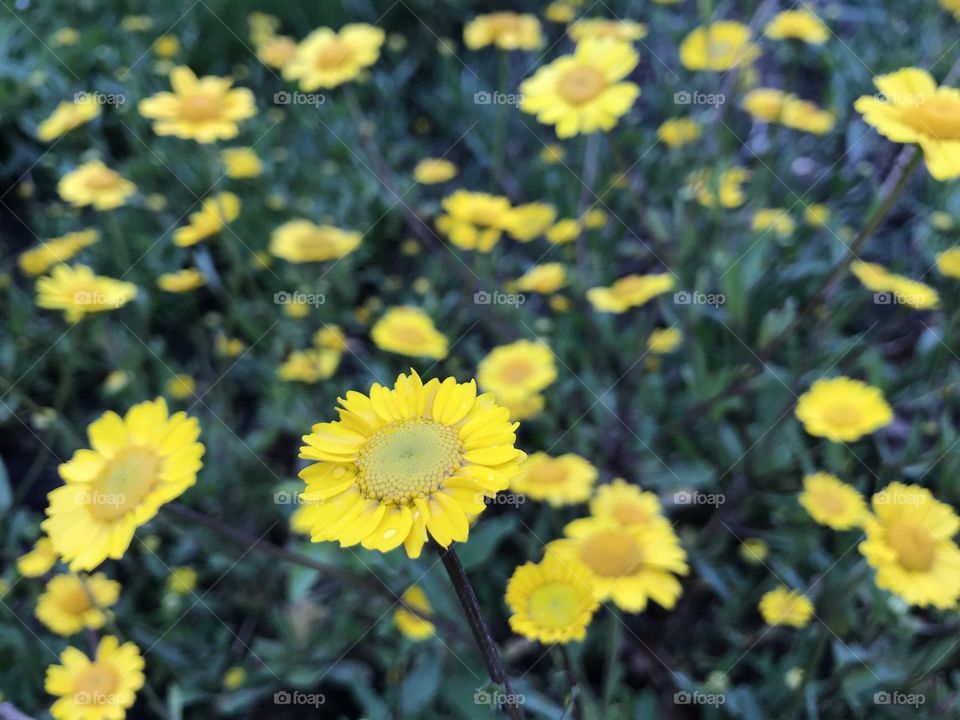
[504, 555, 600, 644]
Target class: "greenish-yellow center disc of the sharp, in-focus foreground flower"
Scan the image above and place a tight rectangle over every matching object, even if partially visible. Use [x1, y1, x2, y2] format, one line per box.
[357, 418, 463, 504]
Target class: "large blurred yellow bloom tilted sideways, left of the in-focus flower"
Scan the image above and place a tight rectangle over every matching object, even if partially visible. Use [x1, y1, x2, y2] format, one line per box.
[41, 398, 203, 571]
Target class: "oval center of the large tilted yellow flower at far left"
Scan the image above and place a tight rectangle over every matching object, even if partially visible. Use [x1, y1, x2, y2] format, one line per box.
[88, 446, 161, 520]
